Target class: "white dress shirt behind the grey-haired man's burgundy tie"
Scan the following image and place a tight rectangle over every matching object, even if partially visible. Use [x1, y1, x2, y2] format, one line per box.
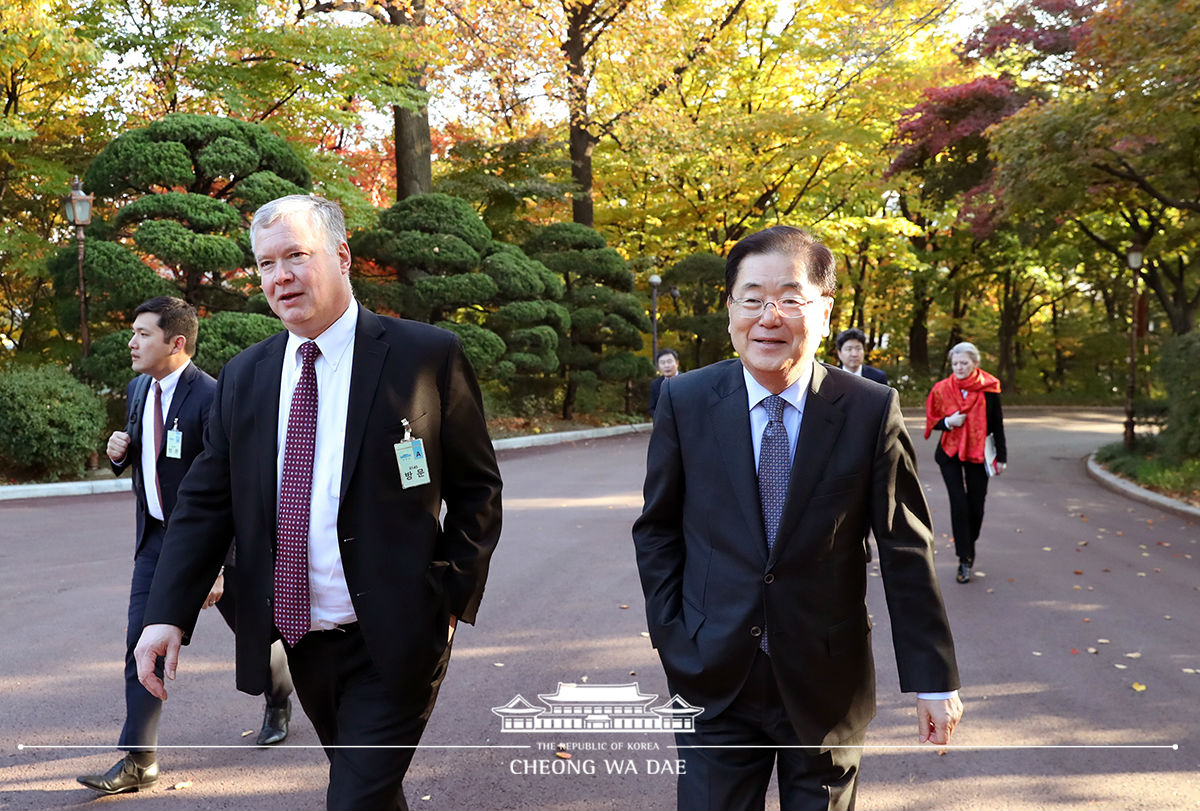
[275, 299, 359, 631]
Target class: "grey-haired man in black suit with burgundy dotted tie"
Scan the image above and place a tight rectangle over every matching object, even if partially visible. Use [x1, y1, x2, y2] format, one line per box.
[137, 196, 500, 811]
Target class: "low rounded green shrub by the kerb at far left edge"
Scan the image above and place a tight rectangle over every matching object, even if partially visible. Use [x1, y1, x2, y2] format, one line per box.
[0, 366, 106, 481]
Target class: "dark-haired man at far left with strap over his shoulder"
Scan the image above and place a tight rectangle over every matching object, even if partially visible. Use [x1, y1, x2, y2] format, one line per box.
[79, 296, 216, 794]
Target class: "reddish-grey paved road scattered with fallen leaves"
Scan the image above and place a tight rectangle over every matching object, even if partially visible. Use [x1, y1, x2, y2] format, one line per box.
[0, 409, 1200, 811]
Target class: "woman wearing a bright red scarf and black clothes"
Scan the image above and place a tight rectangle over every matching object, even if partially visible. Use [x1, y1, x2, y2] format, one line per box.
[925, 342, 1008, 583]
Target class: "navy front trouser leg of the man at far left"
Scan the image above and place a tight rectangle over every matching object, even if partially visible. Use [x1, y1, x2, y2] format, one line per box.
[116, 515, 164, 752]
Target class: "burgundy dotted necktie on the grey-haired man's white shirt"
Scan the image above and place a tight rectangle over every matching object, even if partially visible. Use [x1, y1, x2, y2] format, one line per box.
[275, 341, 320, 645]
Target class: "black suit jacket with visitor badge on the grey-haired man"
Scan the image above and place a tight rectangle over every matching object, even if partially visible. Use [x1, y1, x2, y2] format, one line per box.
[145, 307, 500, 703]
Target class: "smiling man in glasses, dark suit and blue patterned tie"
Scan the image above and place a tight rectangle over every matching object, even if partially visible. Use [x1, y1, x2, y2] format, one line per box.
[634, 226, 962, 811]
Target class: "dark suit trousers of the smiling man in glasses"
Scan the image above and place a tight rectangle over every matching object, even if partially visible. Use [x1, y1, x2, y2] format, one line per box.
[676, 650, 863, 811]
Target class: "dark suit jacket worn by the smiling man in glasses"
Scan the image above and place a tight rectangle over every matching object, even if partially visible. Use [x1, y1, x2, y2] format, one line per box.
[634, 360, 959, 745]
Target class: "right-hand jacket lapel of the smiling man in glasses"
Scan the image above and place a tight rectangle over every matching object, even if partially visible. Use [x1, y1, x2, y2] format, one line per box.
[770, 364, 846, 563]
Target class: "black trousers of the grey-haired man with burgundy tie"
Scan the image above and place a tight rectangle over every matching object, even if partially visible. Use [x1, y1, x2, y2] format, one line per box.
[284, 624, 450, 811]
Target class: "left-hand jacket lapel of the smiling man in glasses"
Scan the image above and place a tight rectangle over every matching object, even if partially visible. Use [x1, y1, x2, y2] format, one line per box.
[710, 361, 767, 561]
